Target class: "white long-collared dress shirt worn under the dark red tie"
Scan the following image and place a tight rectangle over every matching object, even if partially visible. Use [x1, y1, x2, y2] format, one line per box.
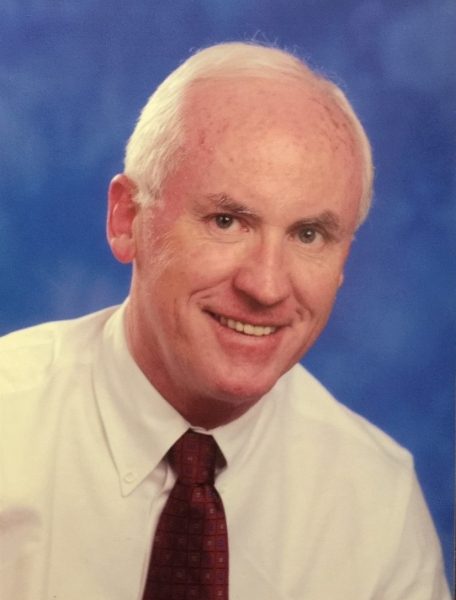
[0, 309, 450, 600]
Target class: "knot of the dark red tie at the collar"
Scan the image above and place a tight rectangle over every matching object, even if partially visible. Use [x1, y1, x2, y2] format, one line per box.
[168, 429, 220, 485]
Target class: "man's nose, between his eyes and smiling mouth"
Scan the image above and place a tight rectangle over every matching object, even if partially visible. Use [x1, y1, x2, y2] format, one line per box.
[233, 236, 291, 306]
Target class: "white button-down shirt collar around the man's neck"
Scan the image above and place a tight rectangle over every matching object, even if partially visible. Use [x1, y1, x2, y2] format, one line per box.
[94, 300, 275, 495]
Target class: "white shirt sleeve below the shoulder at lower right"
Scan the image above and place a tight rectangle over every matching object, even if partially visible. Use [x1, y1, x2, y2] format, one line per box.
[375, 474, 451, 600]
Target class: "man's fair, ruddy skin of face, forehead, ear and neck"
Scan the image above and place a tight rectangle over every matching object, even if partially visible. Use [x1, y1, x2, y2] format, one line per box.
[108, 78, 362, 429]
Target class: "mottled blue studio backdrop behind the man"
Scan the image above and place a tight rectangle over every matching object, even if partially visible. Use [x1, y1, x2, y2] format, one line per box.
[0, 0, 456, 577]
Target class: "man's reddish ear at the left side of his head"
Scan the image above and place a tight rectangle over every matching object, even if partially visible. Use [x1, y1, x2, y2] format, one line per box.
[106, 174, 138, 263]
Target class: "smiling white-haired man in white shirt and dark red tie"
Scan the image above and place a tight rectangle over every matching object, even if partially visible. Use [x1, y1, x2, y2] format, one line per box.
[0, 43, 449, 600]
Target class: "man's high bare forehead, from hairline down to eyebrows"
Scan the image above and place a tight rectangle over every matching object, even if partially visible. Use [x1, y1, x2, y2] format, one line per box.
[157, 73, 362, 226]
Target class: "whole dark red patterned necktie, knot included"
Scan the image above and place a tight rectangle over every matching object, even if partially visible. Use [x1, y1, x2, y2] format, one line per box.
[143, 430, 228, 600]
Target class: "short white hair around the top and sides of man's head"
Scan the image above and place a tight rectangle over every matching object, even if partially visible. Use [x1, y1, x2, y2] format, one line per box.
[125, 42, 374, 225]
